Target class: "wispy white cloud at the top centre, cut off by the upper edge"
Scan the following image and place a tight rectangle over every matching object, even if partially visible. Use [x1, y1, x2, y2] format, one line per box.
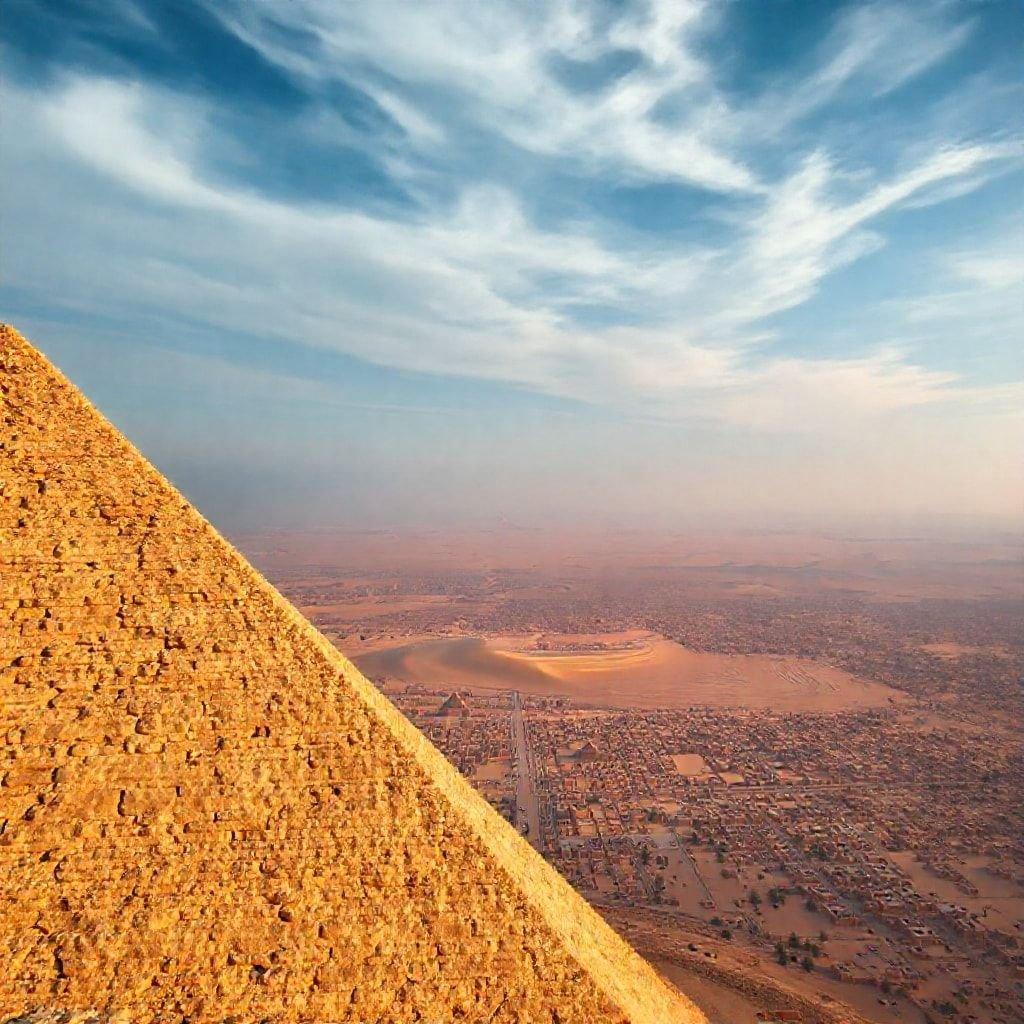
[216, 0, 756, 191]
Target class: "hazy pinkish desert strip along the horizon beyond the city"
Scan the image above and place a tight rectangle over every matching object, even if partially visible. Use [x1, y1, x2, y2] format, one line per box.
[241, 523, 1024, 602]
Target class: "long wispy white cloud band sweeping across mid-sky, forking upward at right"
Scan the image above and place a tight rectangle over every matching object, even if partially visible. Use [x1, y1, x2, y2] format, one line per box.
[20, 49, 1010, 418]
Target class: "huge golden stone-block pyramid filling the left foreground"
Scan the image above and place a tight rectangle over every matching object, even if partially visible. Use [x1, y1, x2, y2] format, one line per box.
[0, 327, 703, 1024]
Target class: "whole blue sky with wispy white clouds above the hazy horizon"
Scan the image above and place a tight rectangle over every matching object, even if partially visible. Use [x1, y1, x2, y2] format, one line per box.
[0, 0, 1024, 531]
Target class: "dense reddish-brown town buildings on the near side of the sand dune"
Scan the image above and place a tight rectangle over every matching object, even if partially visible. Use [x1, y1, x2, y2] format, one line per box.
[380, 686, 1024, 1022]
